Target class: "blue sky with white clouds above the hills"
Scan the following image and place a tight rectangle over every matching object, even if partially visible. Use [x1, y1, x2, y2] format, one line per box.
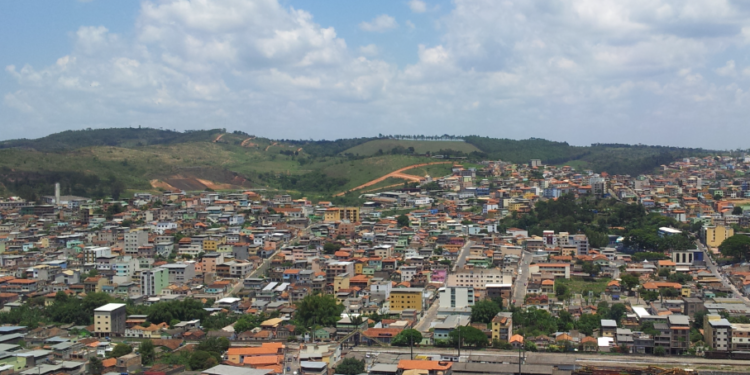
[0, 0, 750, 149]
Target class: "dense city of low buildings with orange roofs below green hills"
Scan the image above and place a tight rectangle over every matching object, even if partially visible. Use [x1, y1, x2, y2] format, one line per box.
[0, 151, 750, 374]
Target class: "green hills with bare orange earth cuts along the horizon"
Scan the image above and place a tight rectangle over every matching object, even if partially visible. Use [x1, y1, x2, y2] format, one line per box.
[0, 128, 720, 200]
